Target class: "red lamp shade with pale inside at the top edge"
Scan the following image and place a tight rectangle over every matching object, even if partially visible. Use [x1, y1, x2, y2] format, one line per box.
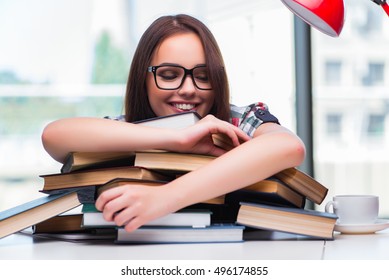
[281, 0, 344, 37]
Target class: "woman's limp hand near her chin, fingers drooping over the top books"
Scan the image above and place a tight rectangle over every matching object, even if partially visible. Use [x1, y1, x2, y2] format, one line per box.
[170, 115, 250, 156]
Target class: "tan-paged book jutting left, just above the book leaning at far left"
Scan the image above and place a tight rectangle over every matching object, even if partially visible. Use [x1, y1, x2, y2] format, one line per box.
[40, 166, 172, 192]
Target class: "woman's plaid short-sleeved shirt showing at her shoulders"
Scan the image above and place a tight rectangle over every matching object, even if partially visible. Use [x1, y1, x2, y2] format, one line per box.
[105, 102, 279, 137]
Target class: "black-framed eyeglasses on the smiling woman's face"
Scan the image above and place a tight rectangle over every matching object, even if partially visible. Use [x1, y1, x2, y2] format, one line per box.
[147, 65, 212, 90]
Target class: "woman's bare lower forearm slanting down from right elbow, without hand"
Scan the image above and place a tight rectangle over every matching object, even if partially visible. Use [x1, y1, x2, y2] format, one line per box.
[162, 128, 305, 211]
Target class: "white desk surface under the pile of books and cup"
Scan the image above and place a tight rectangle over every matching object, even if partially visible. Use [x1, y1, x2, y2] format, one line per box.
[0, 229, 389, 260]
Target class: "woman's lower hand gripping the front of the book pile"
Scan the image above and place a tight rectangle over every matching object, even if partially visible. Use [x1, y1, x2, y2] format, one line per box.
[96, 185, 177, 232]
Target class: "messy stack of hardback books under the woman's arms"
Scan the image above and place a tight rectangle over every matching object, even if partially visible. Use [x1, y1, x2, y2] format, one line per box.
[0, 112, 336, 243]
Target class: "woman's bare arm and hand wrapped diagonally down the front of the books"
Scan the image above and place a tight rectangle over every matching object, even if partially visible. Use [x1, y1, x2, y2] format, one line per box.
[96, 123, 305, 231]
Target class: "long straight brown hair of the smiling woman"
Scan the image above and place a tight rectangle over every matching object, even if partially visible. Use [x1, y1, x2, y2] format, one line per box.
[125, 14, 230, 122]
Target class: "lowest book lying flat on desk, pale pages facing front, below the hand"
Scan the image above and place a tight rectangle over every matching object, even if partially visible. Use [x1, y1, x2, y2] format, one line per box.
[116, 224, 244, 243]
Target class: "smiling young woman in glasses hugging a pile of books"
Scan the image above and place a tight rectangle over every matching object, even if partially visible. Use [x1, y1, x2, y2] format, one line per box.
[42, 15, 305, 231]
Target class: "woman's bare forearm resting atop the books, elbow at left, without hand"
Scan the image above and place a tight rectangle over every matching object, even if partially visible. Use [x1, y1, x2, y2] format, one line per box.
[42, 118, 175, 162]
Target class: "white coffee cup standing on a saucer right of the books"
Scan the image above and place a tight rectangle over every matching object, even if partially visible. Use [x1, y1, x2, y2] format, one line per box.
[325, 195, 379, 225]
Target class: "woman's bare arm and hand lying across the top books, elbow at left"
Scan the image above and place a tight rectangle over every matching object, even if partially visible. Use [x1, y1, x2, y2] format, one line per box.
[42, 116, 249, 162]
